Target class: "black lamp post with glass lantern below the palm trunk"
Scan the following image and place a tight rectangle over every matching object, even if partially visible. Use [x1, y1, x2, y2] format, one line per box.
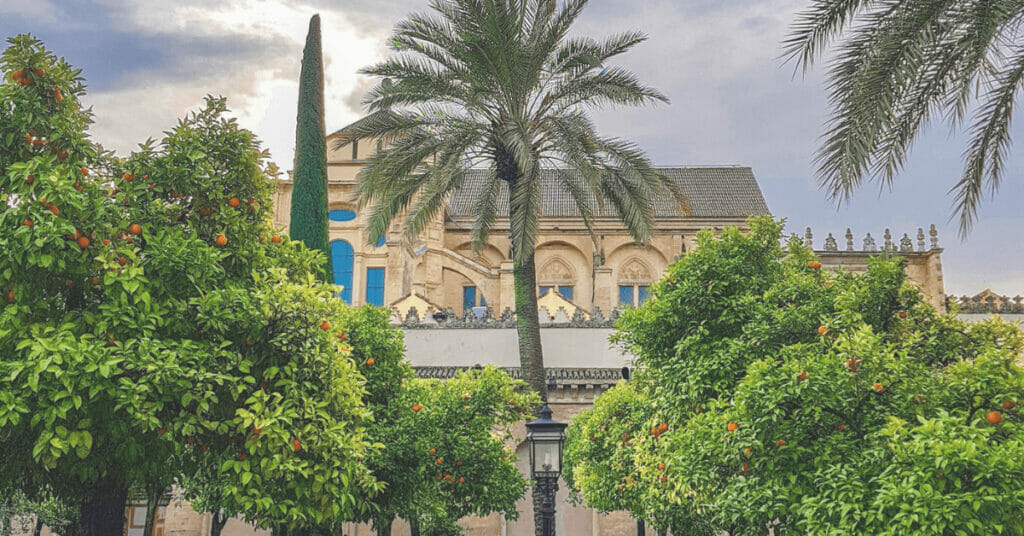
[526, 405, 568, 536]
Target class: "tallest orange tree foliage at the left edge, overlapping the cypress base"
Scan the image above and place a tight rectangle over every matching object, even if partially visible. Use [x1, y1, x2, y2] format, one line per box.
[0, 36, 379, 535]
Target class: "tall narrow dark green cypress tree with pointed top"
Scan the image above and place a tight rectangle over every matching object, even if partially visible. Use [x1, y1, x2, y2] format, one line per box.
[290, 14, 334, 281]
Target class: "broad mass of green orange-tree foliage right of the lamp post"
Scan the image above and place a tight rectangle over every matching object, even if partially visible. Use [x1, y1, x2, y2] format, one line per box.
[566, 219, 1024, 535]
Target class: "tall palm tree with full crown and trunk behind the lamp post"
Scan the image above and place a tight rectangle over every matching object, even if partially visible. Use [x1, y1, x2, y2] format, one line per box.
[339, 0, 668, 397]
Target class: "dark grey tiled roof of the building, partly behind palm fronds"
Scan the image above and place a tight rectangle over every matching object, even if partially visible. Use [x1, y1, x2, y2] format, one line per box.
[449, 166, 769, 218]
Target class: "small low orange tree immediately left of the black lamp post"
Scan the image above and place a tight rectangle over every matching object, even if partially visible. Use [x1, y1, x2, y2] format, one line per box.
[375, 366, 540, 536]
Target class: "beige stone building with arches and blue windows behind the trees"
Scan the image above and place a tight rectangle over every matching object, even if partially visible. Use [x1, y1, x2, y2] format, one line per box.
[140, 121, 945, 536]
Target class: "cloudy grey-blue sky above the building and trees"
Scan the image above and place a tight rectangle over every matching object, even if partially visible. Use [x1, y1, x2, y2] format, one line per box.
[0, 0, 1024, 295]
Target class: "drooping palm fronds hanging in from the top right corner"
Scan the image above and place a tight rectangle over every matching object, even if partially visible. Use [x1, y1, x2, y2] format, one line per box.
[785, 0, 1024, 236]
